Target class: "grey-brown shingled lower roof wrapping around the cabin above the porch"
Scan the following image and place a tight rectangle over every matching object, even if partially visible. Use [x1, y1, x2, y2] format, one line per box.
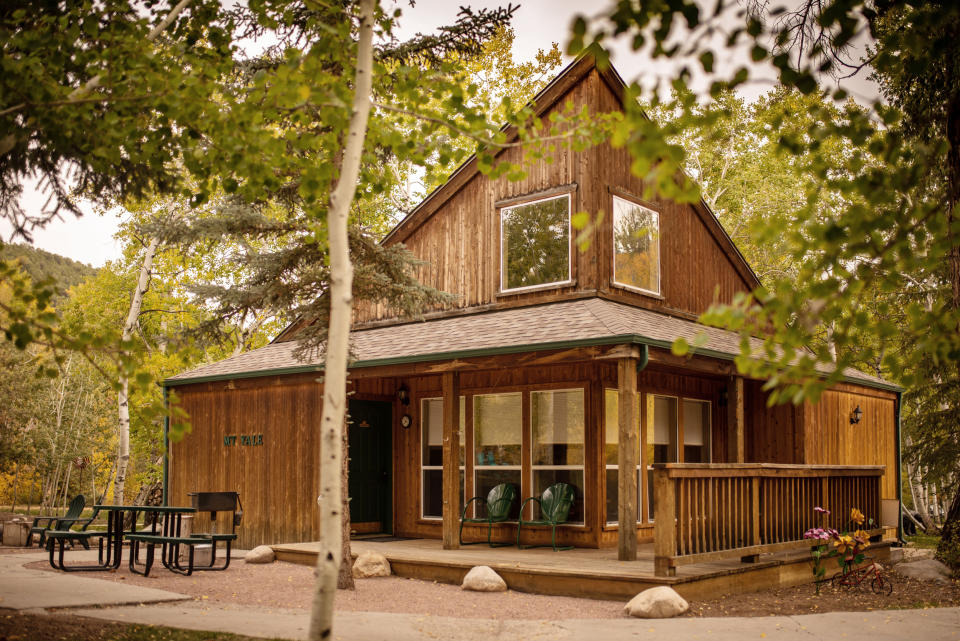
[165, 298, 899, 390]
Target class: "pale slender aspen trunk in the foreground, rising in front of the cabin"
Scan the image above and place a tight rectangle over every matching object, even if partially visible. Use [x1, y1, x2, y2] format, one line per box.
[308, 0, 375, 641]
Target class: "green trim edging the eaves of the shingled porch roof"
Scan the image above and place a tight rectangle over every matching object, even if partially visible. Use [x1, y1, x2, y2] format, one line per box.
[163, 334, 903, 392]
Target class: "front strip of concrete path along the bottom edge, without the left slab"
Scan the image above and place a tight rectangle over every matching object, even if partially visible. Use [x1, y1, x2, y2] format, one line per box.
[69, 602, 960, 641]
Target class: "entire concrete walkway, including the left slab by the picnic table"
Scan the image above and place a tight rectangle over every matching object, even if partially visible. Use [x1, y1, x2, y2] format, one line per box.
[0, 552, 960, 641]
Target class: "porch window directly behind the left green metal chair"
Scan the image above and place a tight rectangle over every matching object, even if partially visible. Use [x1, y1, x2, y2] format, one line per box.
[470, 392, 523, 519]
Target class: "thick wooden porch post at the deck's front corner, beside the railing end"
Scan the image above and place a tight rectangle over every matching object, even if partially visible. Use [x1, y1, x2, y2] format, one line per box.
[617, 358, 638, 561]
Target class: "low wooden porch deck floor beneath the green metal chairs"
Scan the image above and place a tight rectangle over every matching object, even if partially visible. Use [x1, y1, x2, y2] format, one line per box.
[271, 539, 889, 600]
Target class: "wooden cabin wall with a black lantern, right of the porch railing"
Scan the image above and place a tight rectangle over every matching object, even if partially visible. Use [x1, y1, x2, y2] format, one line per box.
[804, 385, 900, 500]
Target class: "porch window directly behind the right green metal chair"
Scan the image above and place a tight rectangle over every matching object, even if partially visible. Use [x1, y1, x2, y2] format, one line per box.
[530, 389, 586, 523]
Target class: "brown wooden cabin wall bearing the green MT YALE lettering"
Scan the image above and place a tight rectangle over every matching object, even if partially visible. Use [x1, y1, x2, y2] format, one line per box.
[168, 374, 393, 549]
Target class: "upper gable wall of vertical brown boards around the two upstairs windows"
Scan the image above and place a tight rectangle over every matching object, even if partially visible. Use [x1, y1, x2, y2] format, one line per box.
[355, 69, 751, 323]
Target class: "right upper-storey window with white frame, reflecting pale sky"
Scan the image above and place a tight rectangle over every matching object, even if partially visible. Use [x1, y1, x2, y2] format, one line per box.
[613, 196, 660, 294]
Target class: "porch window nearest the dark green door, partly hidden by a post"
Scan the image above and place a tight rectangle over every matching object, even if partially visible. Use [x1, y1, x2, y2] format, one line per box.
[420, 396, 466, 519]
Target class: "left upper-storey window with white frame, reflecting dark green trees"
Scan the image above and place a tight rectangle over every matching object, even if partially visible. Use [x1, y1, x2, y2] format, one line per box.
[500, 194, 572, 292]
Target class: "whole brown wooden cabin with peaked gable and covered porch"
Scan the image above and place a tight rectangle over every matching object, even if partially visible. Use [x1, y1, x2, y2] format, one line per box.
[165, 57, 899, 574]
